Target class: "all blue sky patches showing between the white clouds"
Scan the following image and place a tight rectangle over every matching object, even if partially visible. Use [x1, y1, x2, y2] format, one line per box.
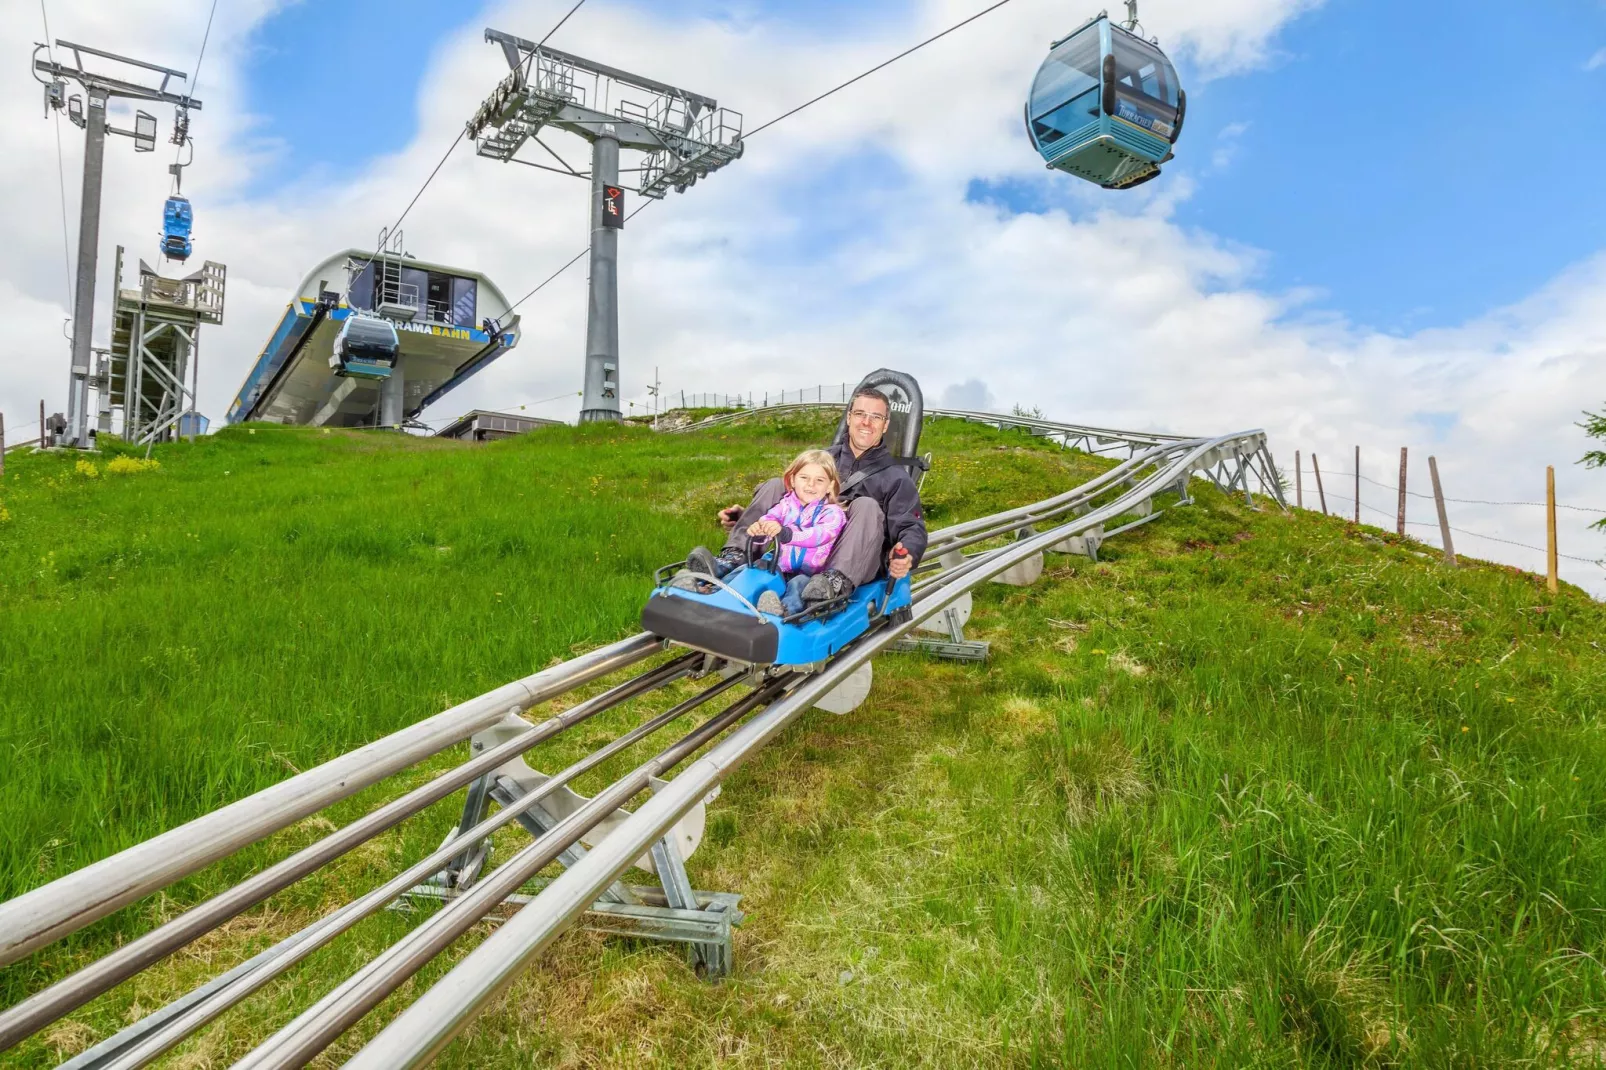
[247, 0, 1606, 333]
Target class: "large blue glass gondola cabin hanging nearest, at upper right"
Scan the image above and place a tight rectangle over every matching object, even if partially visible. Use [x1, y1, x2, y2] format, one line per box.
[1026, 14, 1187, 190]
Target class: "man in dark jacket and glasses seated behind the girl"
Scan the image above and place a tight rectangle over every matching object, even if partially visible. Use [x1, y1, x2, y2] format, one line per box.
[686, 387, 925, 602]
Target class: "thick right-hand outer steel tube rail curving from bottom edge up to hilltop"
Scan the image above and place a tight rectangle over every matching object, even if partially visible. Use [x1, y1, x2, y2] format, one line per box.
[345, 432, 1259, 1070]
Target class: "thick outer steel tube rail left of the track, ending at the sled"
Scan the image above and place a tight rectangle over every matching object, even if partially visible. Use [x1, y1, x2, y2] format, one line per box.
[0, 633, 660, 966]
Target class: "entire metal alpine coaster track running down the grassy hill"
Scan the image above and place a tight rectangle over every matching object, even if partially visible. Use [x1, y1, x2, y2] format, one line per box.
[0, 406, 1283, 1070]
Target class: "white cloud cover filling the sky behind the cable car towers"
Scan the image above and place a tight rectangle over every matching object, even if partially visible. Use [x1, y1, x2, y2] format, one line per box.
[0, 0, 1606, 591]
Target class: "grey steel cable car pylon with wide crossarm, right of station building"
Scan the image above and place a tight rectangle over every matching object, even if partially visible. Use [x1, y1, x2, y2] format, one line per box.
[467, 29, 742, 423]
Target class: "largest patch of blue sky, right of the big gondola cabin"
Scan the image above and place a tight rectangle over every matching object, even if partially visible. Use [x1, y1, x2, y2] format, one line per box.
[1179, 0, 1606, 331]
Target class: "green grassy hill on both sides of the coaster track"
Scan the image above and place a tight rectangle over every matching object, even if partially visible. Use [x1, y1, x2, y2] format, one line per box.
[0, 421, 1606, 1067]
